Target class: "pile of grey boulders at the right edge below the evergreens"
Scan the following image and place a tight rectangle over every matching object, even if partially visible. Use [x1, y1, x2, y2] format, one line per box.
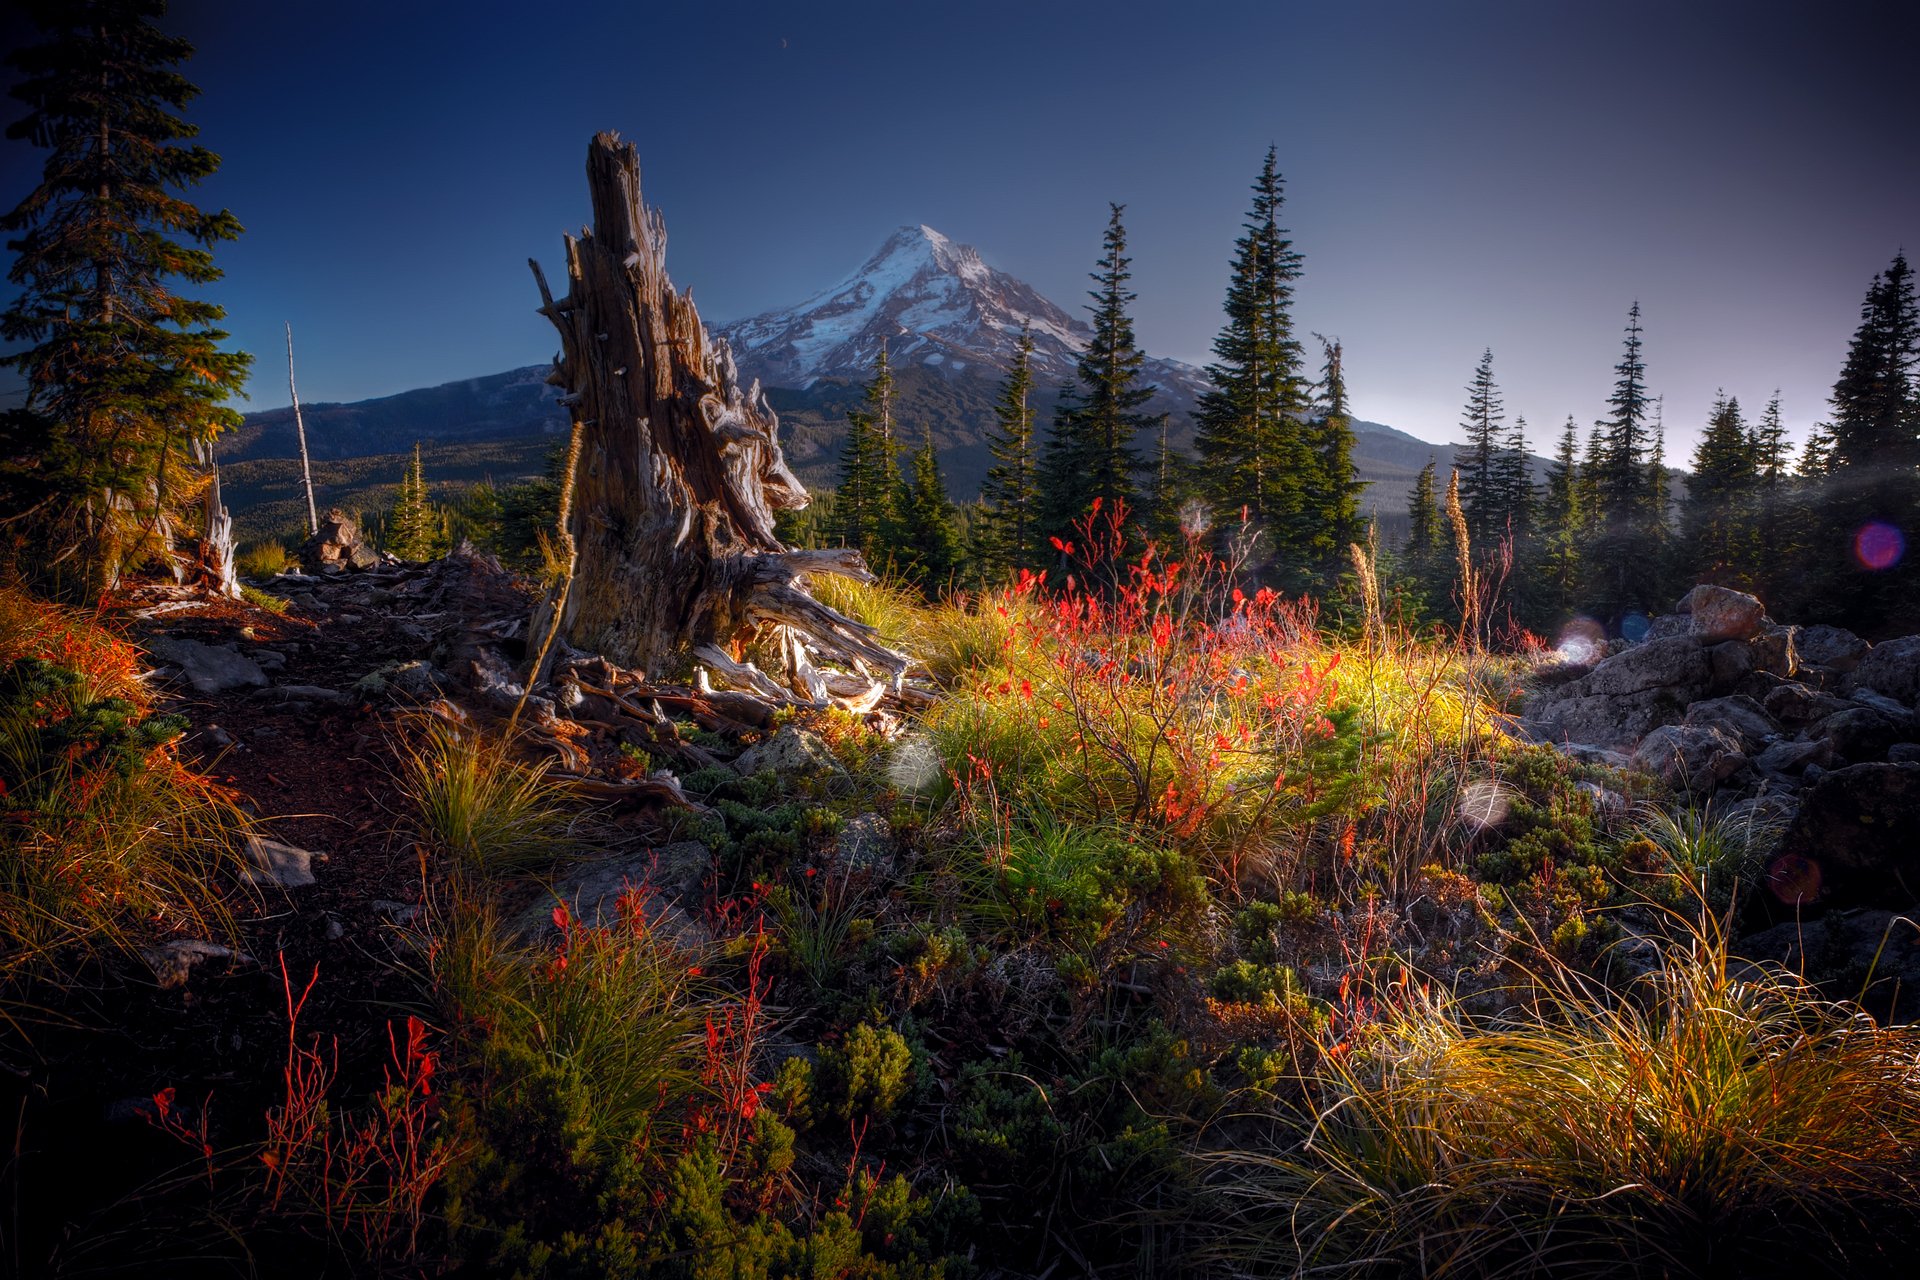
[1521, 585, 1920, 910]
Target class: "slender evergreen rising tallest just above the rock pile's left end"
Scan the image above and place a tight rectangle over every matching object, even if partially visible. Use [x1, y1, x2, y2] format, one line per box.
[1590, 301, 1665, 622]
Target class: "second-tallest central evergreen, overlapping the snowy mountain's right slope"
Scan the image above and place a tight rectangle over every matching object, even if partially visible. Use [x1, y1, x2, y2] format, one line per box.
[1043, 205, 1154, 535]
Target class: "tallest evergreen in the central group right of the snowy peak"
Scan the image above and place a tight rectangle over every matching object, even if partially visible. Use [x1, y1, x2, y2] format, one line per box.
[1196, 148, 1313, 566]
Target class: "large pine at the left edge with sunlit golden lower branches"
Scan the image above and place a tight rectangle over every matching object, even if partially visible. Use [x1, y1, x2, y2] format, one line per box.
[0, 0, 250, 595]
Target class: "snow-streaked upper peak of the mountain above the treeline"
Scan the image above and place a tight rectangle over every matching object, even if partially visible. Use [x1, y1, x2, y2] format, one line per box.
[714, 226, 1206, 407]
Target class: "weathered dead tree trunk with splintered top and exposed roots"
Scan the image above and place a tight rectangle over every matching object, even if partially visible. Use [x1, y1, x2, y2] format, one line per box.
[532, 132, 908, 704]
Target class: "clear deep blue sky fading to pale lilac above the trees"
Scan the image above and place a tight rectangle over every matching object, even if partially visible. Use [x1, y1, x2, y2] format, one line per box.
[0, 0, 1920, 462]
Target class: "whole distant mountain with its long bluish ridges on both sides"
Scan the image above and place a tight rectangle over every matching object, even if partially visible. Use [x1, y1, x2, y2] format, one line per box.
[221, 225, 1520, 528]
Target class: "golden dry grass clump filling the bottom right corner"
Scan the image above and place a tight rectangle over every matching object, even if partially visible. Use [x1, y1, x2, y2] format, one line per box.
[1204, 909, 1920, 1276]
